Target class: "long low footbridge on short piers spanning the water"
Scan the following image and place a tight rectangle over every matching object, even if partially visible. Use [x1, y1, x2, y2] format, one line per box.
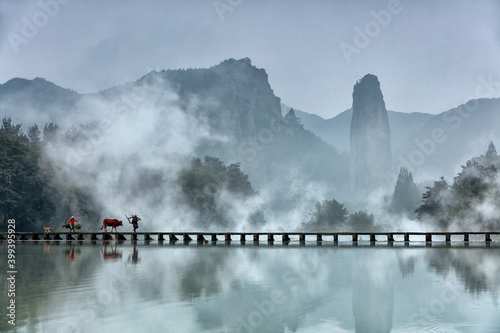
[0, 231, 500, 244]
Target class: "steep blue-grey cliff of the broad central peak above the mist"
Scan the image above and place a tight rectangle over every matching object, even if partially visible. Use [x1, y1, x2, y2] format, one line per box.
[160, 58, 282, 141]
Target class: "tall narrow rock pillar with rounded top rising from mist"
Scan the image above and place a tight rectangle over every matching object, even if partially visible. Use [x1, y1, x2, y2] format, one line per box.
[350, 74, 392, 190]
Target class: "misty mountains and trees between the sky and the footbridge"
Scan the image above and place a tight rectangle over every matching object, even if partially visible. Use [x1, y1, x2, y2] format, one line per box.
[0, 58, 500, 232]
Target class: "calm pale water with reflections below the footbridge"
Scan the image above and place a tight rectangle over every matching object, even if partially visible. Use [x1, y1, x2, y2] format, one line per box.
[0, 241, 500, 333]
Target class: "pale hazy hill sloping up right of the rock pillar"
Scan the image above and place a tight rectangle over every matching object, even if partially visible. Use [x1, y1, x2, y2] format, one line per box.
[394, 98, 500, 180]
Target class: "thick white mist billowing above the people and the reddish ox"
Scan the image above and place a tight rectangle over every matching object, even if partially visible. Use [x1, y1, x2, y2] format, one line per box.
[39, 72, 268, 231]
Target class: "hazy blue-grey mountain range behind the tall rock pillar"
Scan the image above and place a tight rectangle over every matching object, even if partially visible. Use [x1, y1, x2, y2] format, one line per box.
[0, 59, 500, 189]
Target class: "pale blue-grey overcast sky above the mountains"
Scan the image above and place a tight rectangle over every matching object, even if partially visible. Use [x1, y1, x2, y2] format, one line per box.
[0, 0, 500, 118]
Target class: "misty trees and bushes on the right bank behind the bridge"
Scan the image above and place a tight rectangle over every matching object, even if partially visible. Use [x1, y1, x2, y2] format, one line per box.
[299, 142, 500, 231]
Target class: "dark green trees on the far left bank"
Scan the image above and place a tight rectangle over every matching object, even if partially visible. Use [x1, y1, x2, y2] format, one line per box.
[0, 118, 97, 231]
